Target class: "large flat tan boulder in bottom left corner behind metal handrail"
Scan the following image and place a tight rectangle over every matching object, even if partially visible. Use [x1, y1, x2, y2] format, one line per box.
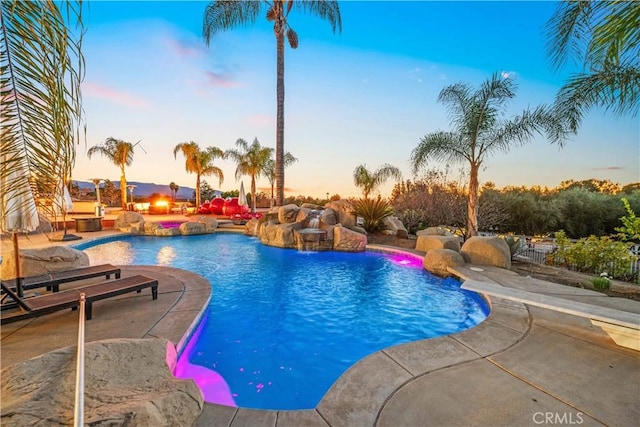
[0, 338, 204, 427]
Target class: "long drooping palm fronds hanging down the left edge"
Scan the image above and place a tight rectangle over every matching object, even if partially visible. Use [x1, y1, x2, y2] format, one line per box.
[0, 0, 84, 231]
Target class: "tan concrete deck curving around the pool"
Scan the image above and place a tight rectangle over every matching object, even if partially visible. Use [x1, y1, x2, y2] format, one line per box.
[1, 222, 640, 427]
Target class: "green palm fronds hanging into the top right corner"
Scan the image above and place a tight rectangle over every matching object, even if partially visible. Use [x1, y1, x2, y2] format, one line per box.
[547, 1, 640, 132]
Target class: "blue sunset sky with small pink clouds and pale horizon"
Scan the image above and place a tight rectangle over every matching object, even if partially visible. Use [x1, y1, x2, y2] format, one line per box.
[73, 1, 640, 197]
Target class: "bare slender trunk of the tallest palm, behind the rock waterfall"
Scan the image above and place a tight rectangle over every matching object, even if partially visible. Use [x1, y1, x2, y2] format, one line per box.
[276, 25, 284, 206]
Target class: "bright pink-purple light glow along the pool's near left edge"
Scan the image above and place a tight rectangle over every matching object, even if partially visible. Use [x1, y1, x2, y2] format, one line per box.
[173, 319, 238, 407]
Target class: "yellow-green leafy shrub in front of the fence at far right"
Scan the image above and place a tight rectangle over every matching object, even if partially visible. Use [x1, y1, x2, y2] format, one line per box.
[551, 231, 634, 278]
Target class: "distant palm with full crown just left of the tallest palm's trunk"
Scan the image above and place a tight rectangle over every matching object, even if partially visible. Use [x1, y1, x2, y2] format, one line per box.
[224, 138, 273, 213]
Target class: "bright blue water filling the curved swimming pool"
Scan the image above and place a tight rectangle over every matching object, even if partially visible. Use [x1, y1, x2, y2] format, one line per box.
[81, 233, 488, 409]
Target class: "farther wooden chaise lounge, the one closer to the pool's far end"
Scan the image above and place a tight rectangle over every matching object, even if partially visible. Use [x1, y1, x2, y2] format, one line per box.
[3, 264, 120, 292]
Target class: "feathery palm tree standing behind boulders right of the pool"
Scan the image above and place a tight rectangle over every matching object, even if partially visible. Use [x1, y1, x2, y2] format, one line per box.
[411, 74, 568, 241]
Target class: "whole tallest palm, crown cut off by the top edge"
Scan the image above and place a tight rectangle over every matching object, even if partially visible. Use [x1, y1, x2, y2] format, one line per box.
[202, 0, 342, 206]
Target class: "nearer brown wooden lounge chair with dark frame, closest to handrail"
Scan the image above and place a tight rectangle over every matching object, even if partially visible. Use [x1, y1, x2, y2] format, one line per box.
[0, 275, 158, 324]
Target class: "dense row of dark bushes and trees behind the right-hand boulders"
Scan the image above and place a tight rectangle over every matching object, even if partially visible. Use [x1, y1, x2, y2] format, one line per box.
[390, 175, 640, 239]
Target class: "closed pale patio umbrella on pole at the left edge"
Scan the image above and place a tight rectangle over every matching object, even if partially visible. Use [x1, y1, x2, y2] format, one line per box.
[0, 154, 40, 296]
